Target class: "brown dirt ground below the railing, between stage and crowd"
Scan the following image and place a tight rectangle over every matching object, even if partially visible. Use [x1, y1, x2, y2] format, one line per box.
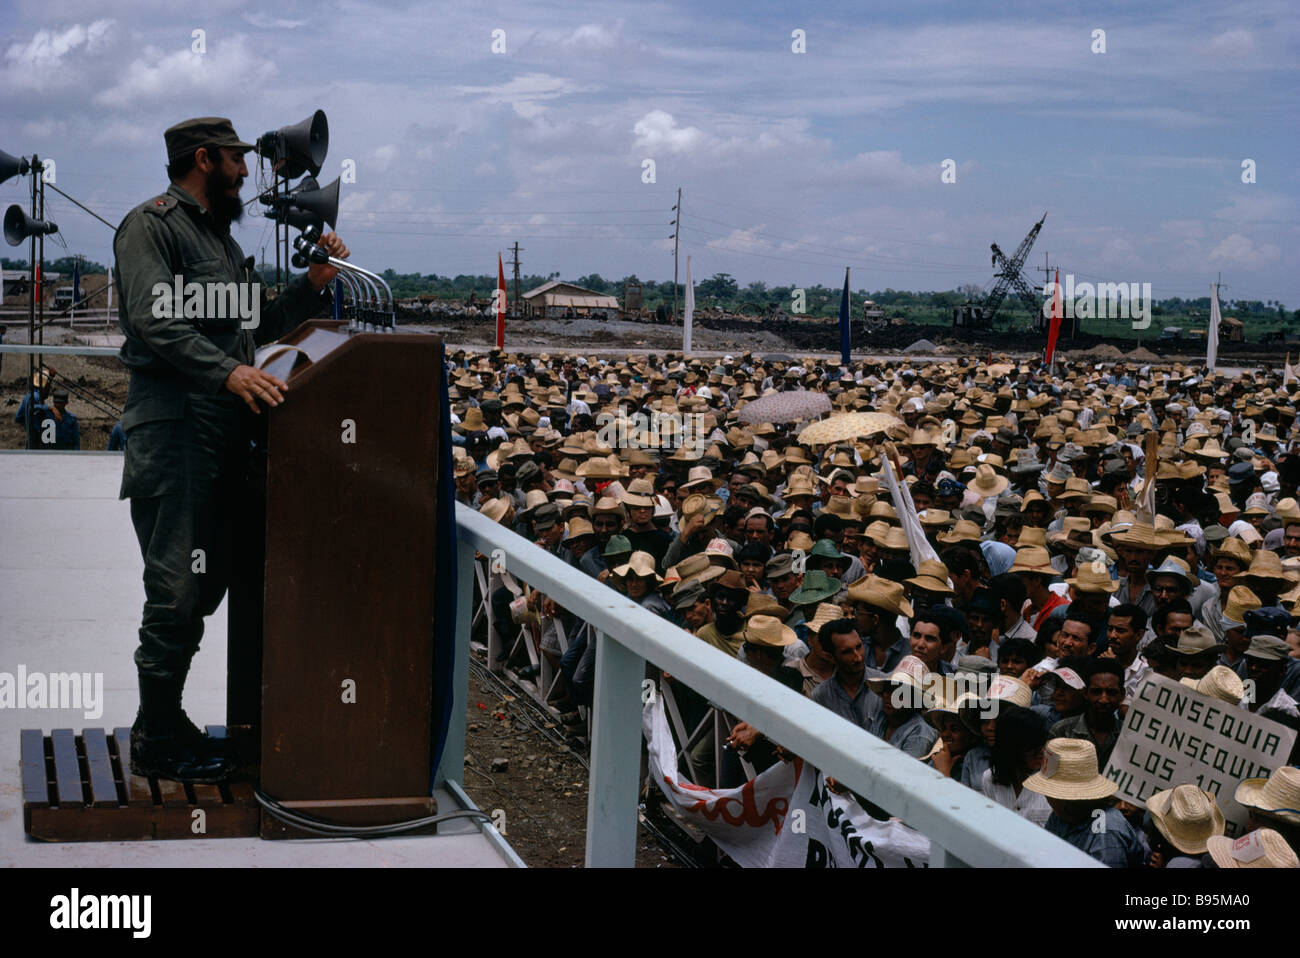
[464, 657, 677, 868]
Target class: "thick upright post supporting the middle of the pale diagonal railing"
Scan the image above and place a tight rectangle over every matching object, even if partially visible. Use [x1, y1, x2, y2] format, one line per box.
[586, 630, 646, 868]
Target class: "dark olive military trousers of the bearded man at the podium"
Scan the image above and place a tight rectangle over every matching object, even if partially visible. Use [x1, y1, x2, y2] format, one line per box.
[122, 398, 250, 682]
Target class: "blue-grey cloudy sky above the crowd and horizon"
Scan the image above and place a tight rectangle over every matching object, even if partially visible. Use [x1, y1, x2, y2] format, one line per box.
[0, 0, 1300, 302]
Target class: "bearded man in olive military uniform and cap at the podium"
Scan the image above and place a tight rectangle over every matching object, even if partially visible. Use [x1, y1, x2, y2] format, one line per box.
[113, 117, 348, 783]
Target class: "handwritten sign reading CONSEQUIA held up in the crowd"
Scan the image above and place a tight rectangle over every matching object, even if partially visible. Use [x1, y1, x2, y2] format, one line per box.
[1105, 675, 1296, 837]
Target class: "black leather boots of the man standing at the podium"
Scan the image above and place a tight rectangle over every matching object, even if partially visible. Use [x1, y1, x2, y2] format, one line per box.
[131, 676, 233, 784]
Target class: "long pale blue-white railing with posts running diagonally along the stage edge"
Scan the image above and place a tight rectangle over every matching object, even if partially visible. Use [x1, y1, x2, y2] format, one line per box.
[439, 503, 1101, 867]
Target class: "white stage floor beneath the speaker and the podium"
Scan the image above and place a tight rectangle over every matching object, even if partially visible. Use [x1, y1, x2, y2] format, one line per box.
[0, 451, 517, 867]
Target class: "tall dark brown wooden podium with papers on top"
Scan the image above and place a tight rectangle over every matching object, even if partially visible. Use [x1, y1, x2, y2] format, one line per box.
[228, 320, 449, 838]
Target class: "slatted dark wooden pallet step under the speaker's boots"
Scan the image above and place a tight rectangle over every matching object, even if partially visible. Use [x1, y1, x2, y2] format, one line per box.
[21, 727, 259, 841]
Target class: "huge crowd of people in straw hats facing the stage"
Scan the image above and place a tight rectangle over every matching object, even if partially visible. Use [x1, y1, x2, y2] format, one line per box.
[447, 351, 1300, 867]
